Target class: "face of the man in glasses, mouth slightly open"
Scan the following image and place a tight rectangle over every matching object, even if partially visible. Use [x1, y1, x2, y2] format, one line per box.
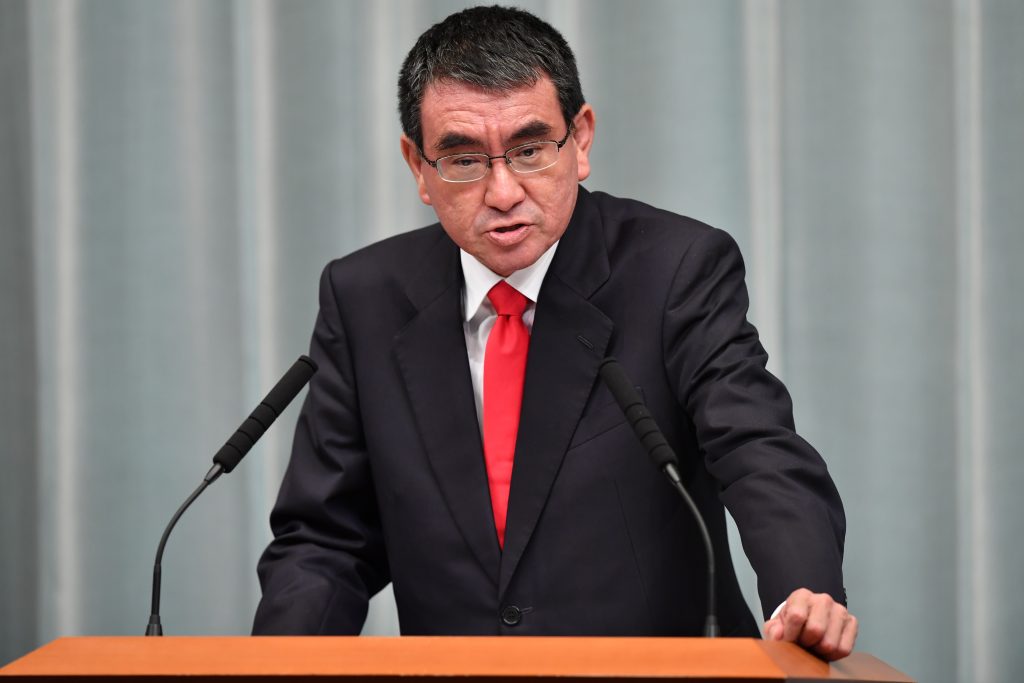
[401, 77, 594, 278]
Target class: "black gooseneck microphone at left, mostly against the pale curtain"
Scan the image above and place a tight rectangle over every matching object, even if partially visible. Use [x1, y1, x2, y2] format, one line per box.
[145, 355, 316, 636]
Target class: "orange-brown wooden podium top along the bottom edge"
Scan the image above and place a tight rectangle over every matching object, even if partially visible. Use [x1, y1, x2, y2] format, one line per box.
[0, 636, 911, 683]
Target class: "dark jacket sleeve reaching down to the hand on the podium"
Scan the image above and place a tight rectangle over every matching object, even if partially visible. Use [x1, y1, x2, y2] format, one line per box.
[663, 230, 846, 618]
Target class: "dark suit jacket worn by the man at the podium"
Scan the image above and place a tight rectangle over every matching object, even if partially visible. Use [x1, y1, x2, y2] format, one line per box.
[254, 188, 845, 636]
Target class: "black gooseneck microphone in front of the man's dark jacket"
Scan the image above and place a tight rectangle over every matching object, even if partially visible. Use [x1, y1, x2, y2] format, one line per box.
[600, 356, 719, 638]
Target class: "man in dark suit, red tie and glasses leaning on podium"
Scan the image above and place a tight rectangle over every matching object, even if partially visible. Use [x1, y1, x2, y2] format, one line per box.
[254, 7, 857, 658]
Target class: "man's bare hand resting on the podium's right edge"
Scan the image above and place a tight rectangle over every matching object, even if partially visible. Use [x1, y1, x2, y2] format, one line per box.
[765, 588, 857, 661]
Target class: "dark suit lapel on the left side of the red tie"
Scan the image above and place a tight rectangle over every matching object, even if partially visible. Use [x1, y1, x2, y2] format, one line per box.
[394, 232, 500, 585]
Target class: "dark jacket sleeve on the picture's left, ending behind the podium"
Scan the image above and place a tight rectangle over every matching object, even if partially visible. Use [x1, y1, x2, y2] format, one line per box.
[253, 265, 389, 635]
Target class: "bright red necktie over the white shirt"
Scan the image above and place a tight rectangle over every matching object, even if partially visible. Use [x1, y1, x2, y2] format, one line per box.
[483, 280, 529, 547]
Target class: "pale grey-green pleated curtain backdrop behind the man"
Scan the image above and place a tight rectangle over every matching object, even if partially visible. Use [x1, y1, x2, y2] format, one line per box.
[0, 0, 1024, 681]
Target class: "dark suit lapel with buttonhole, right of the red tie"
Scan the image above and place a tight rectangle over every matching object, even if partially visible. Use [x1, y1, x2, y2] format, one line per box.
[499, 187, 613, 597]
